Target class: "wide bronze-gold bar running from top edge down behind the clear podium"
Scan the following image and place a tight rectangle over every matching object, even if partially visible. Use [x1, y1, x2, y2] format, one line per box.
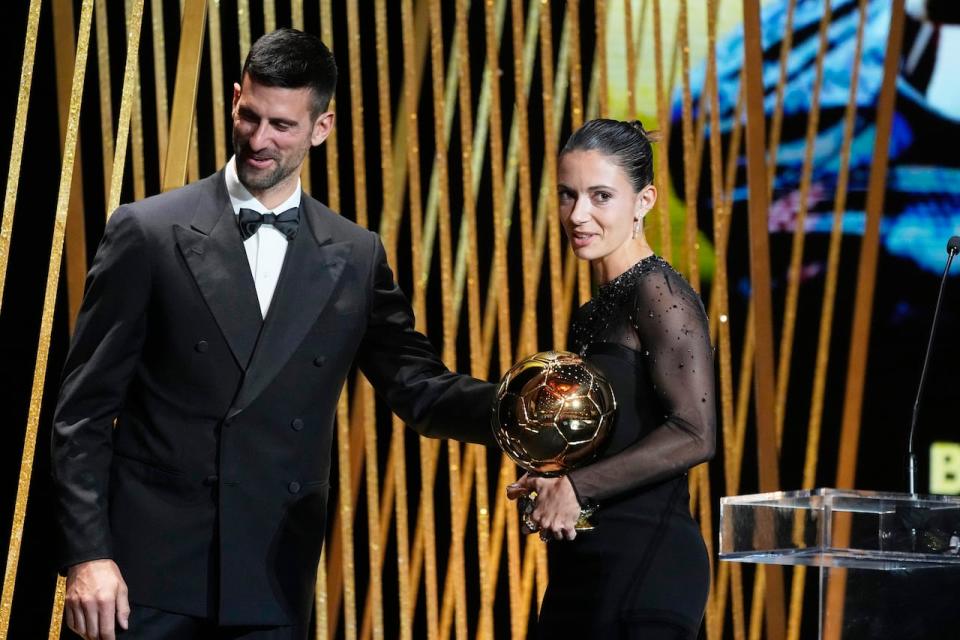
[743, 0, 785, 640]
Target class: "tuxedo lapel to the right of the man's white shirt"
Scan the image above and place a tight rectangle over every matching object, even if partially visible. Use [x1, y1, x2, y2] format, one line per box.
[230, 201, 353, 417]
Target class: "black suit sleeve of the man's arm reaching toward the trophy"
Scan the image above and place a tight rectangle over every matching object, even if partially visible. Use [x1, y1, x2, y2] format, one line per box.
[358, 232, 495, 445]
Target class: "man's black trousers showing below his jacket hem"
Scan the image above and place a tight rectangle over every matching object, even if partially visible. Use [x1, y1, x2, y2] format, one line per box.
[64, 604, 307, 640]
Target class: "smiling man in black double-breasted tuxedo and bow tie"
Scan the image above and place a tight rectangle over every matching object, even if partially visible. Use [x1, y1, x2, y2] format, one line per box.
[53, 29, 493, 639]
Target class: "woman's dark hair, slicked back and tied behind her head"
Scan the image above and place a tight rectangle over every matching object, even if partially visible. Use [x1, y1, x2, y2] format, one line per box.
[560, 118, 657, 192]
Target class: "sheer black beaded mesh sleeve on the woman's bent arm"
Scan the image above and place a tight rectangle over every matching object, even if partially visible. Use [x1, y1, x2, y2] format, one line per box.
[570, 267, 716, 502]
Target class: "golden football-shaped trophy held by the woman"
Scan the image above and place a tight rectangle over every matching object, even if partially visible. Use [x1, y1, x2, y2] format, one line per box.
[492, 351, 617, 531]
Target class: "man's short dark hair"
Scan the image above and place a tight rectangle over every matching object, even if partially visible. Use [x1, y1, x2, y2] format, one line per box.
[241, 29, 337, 118]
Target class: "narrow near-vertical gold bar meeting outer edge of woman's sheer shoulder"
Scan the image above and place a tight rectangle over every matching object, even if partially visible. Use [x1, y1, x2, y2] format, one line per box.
[677, 0, 700, 291]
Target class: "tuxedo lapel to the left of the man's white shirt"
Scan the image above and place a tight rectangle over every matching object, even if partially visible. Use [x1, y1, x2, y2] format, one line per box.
[174, 171, 262, 369]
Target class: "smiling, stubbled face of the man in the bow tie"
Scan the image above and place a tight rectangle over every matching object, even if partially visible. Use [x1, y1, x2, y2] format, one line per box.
[233, 76, 333, 199]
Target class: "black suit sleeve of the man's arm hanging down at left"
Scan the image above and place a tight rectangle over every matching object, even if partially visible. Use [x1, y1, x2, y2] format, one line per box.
[51, 208, 150, 568]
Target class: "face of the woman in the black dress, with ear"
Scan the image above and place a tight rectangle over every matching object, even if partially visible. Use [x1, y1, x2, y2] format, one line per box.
[558, 150, 656, 264]
